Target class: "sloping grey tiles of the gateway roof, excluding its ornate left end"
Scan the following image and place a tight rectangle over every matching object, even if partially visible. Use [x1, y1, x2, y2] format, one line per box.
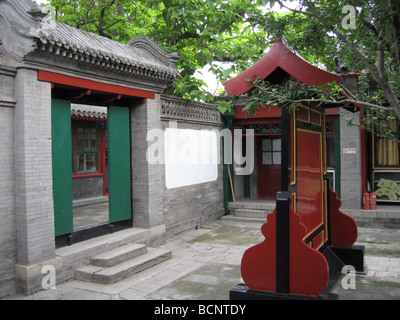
[38, 19, 178, 81]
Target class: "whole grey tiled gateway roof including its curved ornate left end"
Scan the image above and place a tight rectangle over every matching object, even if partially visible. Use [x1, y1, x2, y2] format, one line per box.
[0, 0, 179, 87]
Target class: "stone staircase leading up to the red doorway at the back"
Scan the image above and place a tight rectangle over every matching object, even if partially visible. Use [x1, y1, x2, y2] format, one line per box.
[224, 199, 275, 223]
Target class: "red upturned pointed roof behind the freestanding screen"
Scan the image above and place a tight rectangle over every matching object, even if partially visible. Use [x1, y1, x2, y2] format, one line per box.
[223, 39, 341, 96]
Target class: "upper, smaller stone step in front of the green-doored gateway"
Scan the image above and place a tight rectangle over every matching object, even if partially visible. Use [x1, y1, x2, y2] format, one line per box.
[90, 243, 147, 267]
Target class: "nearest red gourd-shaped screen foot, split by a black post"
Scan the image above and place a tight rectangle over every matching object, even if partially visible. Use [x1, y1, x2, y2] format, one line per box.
[241, 209, 329, 295]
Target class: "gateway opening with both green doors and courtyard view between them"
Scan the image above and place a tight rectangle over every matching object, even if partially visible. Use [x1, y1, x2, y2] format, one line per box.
[52, 99, 132, 245]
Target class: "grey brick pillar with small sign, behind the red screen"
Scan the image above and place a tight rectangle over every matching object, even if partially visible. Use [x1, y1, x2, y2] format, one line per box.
[340, 108, 362, 209]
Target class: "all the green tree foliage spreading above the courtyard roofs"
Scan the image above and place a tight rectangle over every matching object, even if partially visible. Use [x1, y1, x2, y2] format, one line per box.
[39, 0, 400, 129]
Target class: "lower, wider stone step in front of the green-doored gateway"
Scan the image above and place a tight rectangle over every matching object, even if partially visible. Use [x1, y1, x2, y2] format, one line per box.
[76, 248, 172, 284]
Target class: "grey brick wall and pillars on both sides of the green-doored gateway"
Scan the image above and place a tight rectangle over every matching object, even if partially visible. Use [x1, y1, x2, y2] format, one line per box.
[0, 68, 224, 296]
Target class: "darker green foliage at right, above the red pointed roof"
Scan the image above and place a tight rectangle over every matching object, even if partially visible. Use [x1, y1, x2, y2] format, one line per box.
[251, 0, 400, 109]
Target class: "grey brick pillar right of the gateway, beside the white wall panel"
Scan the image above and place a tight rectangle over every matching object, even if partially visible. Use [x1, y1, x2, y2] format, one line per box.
[131, 94, 164, 228]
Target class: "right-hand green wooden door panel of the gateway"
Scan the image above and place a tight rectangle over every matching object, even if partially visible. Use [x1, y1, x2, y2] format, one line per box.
[107, 106, 132, 222]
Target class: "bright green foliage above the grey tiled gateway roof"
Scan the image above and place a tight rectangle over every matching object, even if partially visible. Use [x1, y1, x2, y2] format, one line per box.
[45, 0, 265, 101]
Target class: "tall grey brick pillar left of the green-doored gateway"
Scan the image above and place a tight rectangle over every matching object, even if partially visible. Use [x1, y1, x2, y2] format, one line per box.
[14, 68, 56, 293]
